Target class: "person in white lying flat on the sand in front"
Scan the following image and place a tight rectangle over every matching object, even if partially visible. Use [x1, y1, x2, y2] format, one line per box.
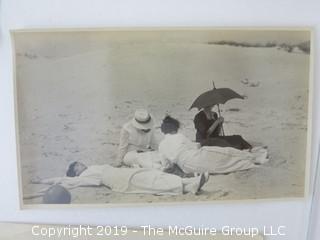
[31, 162, 208, 195]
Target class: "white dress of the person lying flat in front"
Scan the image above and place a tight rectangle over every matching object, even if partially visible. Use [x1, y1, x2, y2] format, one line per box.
[44, 164, 183, 195]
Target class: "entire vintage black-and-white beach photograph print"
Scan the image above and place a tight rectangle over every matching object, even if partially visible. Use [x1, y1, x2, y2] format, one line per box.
[12, 28, 312, 206]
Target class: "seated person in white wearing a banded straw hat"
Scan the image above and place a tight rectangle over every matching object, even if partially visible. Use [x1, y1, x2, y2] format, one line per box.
[117, 109, 159, 168]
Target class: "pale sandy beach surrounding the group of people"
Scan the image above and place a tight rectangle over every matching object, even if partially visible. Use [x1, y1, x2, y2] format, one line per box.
[17, 43, 309, 203]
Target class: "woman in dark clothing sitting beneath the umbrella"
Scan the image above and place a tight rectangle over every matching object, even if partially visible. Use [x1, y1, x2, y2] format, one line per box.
[193, 106, 252, 150]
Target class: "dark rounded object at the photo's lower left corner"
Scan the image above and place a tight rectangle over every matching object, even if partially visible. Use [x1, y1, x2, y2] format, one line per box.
[42, 185, 71, 204]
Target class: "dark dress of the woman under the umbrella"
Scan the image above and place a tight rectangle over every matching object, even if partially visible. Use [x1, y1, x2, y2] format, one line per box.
[193, 111, 252, 150]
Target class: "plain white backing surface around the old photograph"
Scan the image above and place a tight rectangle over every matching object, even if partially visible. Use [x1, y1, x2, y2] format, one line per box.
[0, 0, 320, 240]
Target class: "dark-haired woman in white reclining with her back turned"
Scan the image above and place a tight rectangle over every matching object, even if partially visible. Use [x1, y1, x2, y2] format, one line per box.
[159, 116, 268, 173]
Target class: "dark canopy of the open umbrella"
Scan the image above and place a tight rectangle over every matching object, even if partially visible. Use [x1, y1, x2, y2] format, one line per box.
[189, 88, 244, 110]
